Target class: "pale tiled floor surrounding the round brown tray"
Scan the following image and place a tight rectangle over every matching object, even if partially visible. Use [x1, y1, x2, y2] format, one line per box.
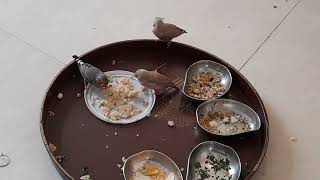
[0, 0, 320, 180]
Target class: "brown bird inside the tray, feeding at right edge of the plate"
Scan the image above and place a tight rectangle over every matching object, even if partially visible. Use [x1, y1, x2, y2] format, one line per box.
[134, 69, 179, 94]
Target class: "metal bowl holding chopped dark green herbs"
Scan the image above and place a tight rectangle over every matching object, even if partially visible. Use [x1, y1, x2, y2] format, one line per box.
[186, 141, 241, 180]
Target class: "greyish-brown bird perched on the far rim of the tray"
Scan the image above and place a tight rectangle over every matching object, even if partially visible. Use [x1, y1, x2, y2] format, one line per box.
[152, 17, 187, 47]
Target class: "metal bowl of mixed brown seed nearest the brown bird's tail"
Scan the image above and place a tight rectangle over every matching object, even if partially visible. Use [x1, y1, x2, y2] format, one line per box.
[182, 60, 232, 101]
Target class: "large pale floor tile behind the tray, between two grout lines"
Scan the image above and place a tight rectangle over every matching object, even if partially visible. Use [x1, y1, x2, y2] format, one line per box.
[0, 0, 298, 68]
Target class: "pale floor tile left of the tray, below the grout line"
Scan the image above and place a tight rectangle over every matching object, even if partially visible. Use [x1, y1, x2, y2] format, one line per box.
[0, 30, 62, 180]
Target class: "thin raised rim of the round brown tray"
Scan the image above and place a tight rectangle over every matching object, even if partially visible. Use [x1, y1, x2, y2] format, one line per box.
[39, 39, 270, 180]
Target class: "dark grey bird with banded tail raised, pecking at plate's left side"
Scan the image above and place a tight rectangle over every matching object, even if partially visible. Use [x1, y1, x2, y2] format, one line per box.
[72, 55, 109, 89]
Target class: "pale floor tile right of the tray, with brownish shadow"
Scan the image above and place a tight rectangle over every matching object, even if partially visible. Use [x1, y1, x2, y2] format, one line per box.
[242, 0, 320, 180]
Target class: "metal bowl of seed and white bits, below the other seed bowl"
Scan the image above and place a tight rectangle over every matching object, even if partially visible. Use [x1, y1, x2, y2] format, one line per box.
[196, 99, 261, 136]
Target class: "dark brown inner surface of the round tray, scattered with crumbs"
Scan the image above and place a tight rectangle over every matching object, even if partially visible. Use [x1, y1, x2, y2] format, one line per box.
[40, 40, 268, 180]
